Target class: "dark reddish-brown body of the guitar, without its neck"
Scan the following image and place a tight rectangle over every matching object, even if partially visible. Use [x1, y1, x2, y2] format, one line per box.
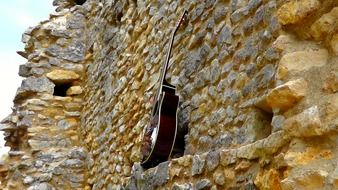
[142, 87, 179, 168]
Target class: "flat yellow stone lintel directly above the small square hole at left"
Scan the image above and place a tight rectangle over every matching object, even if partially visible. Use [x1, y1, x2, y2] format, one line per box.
[46, 69, 80, 83]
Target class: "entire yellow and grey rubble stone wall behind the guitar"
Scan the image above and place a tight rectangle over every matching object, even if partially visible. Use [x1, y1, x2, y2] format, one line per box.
[0, 0, 338, 189]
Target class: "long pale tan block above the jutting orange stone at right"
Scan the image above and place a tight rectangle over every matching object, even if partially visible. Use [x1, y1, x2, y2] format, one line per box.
[277, 49, 329, 79]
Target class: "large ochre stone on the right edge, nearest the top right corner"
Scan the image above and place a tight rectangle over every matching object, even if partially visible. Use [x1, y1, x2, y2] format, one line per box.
[311, 7, 338, 40]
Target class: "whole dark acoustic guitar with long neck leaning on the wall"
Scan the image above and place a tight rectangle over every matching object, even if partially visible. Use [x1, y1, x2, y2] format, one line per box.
[141, 11, 187, 168]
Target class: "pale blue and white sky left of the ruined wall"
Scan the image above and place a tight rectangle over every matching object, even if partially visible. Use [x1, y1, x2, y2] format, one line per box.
[0, 0, 54, 156]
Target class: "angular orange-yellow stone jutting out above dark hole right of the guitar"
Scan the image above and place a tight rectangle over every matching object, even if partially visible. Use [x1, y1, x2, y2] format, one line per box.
[266, 79, 307, 111]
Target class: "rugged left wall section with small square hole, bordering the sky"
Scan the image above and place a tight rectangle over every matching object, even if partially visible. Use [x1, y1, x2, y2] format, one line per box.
[0, 1, 91, 190]
